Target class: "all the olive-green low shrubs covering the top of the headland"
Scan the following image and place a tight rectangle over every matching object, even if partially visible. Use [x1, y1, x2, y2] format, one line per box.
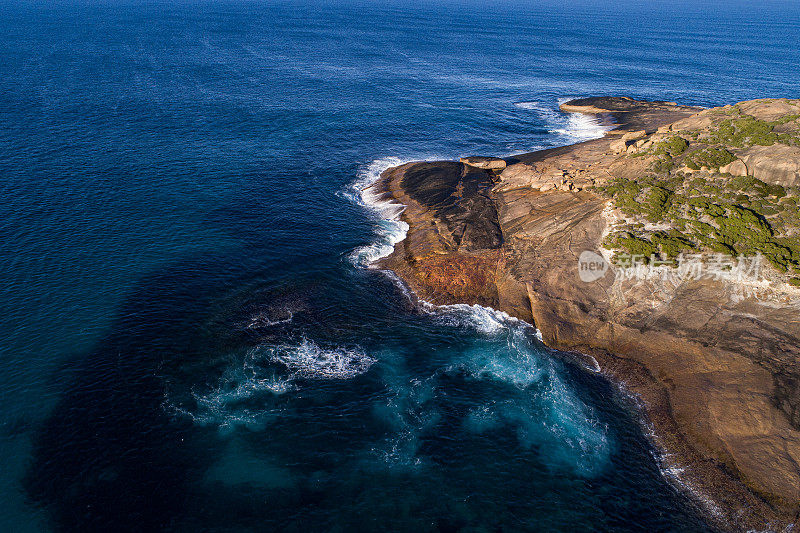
[596, 106, 800, 286]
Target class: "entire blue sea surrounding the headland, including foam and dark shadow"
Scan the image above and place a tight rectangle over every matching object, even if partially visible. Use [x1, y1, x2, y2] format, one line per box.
[0, 0, 800, 532]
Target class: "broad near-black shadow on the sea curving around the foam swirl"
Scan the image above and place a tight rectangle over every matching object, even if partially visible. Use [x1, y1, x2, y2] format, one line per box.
[23, 243, 406, 531]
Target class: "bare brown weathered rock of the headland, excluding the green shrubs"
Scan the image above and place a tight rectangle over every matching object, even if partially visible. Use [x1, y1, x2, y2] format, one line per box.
[375, 98, 800, 530]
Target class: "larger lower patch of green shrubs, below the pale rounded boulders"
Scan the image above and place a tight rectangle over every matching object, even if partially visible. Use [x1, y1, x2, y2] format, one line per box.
[596, 173, 800, 274]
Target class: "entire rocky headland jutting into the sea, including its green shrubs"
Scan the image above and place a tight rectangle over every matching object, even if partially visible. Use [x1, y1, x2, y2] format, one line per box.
[373, 97, 800, 531]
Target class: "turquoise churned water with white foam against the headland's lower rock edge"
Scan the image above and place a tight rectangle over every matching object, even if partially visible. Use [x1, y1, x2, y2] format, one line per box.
[434, 312, 612, 476]
